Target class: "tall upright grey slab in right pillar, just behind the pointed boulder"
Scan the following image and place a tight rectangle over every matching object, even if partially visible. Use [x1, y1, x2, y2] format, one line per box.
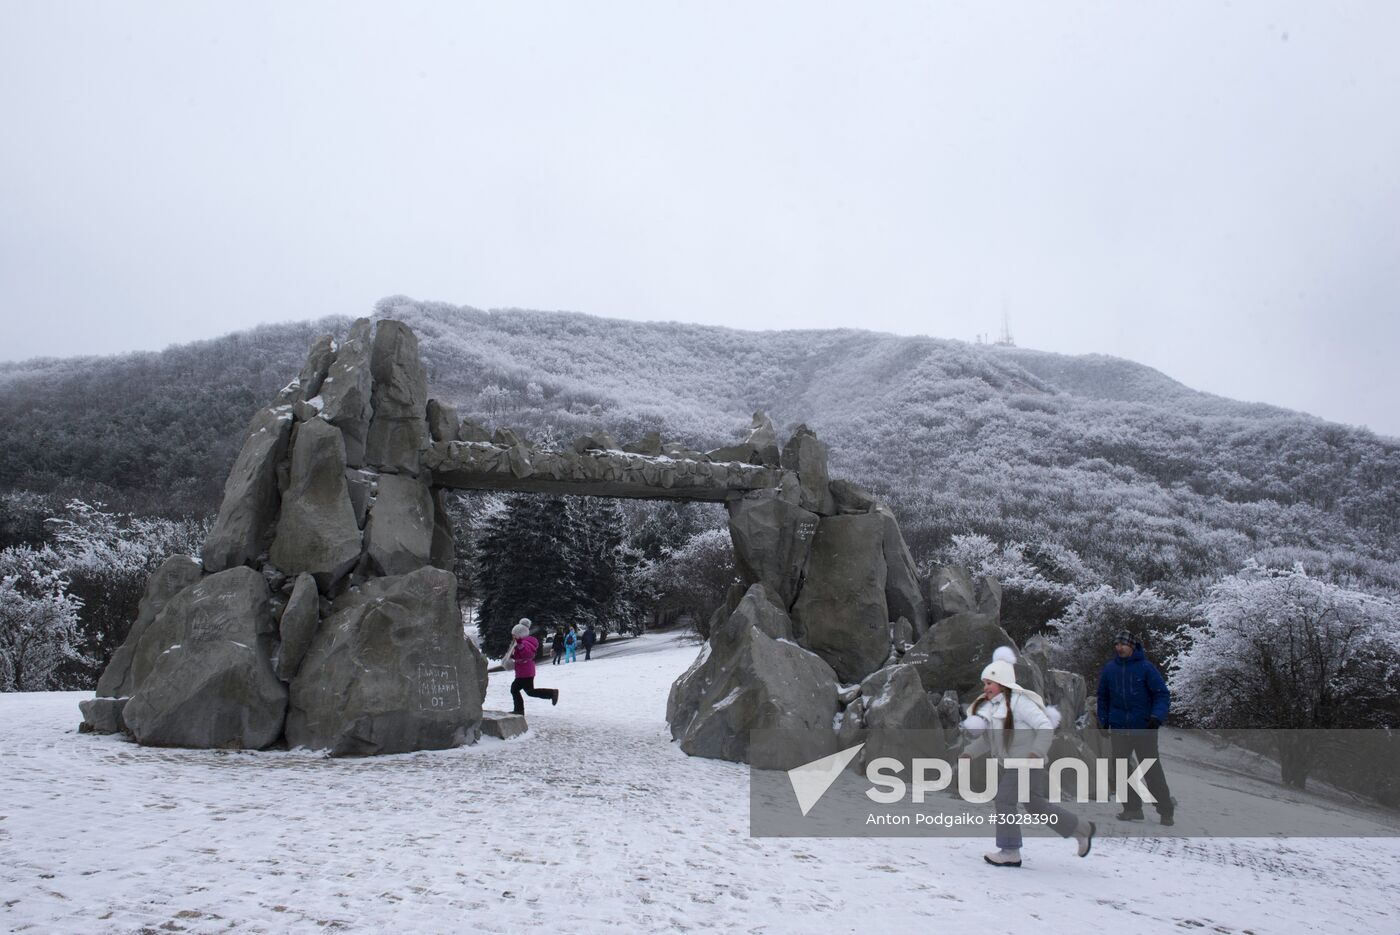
[792, 514, 890, 682]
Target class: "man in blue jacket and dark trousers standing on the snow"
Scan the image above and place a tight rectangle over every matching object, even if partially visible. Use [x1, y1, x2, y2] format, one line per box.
[1099, 631, 1176, 824]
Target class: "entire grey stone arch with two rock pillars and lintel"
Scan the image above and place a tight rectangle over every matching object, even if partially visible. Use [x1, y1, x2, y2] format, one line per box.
[81, 319, 1084, 768]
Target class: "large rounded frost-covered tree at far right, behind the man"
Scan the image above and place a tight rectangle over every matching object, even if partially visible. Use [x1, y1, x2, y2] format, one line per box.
[1173, 563, 1400, 788]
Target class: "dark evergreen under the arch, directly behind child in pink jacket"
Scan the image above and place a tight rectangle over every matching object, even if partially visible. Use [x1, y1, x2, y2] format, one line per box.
[476, 494, 588, 656]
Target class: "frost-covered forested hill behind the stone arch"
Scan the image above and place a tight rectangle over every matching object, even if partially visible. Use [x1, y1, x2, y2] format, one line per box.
[0, 297, 1400, 591]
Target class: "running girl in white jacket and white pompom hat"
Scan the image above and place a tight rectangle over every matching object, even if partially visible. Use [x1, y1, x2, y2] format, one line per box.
[963, 649, 1095, 866]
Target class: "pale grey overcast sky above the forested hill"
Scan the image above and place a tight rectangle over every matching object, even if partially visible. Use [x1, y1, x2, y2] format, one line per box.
[8, 0, 1400, 435]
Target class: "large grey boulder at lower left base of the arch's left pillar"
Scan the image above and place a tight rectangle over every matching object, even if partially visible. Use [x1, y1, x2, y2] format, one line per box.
[122, 567, 287, 749]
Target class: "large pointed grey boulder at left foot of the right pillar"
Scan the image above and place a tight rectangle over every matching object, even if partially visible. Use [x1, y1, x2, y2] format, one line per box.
[666, 585, 837, 770]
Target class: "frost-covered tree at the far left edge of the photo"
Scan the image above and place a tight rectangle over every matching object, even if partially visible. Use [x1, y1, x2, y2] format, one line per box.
[0, 546, 84, 691]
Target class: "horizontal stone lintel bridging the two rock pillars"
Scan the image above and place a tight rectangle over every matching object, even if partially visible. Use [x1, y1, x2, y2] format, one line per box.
[423, 441, 797, 502]
